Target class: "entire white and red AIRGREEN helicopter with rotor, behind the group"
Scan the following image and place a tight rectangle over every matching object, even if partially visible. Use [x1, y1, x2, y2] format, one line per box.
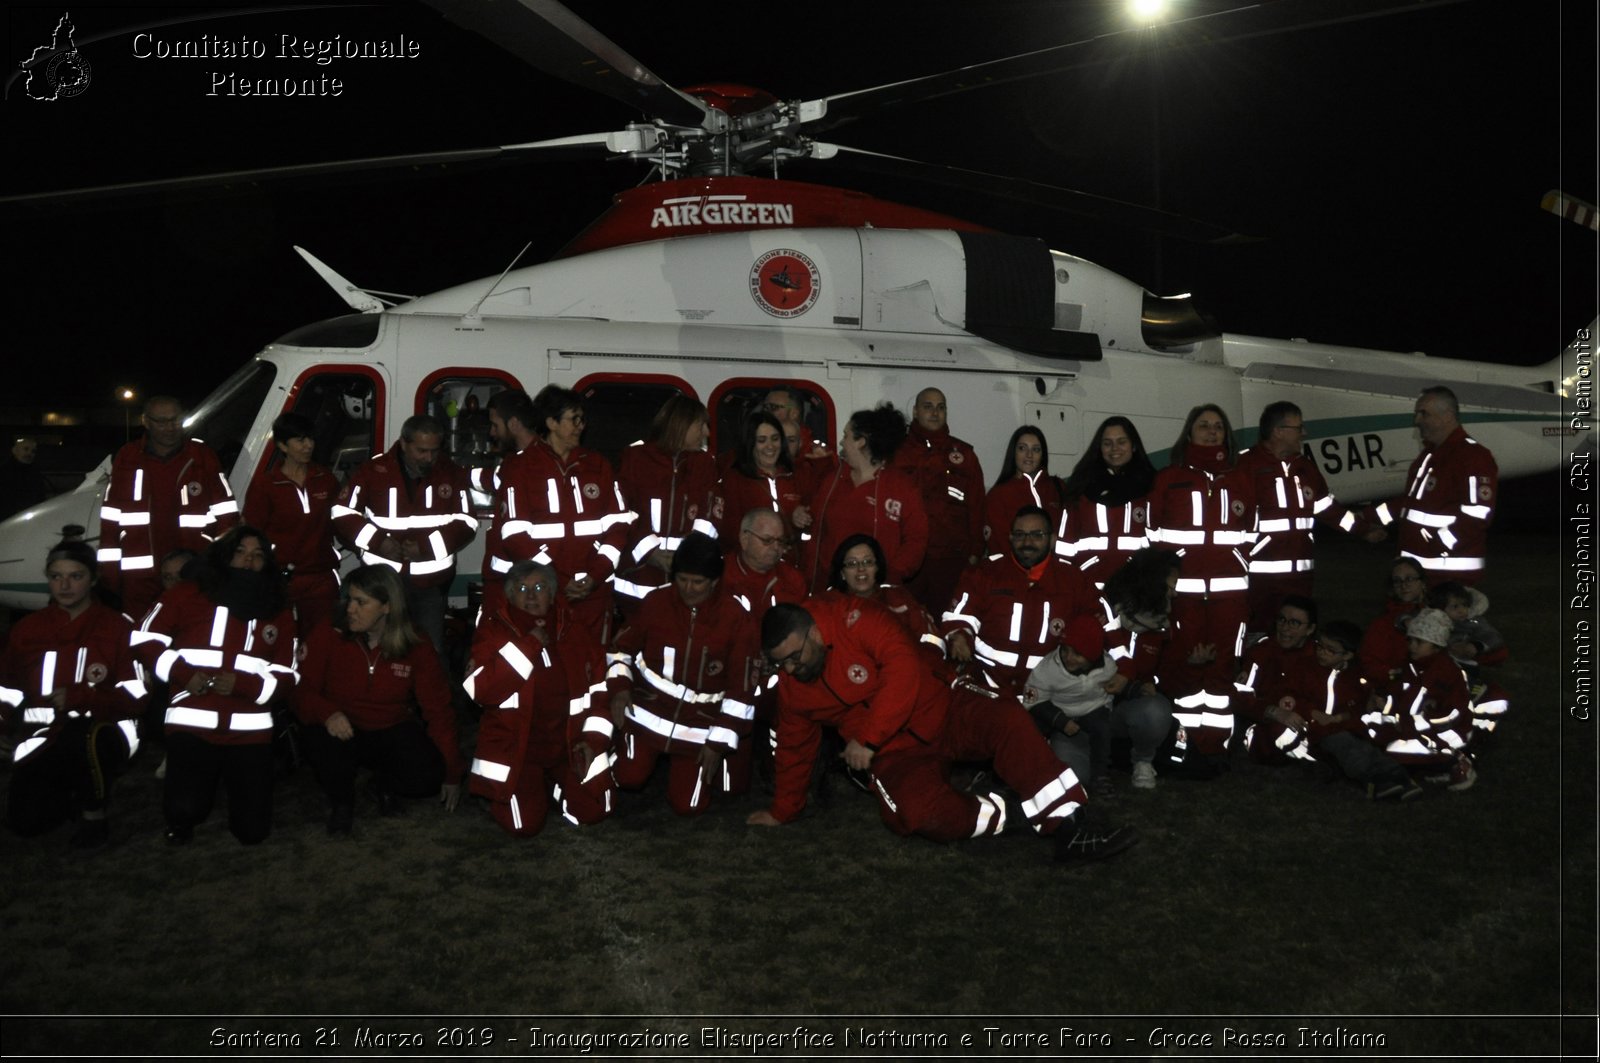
[0, 0, 1570, 608]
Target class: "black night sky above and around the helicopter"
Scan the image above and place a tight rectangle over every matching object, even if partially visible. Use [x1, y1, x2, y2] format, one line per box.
[0, 0, 1597, 403]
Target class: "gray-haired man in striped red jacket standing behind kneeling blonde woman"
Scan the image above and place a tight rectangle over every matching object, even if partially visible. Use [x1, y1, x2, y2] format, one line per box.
[333, 415, 478, 653]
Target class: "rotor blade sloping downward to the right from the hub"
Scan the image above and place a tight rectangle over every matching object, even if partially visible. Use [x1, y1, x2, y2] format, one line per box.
[813, 142, 1261, 245]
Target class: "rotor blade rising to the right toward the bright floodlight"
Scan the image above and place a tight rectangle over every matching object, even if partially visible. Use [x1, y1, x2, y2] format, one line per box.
[805, 0, 1466, 133]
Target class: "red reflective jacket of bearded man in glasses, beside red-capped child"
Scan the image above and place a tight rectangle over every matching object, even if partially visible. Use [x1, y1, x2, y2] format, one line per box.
[942, 554, 1104, 693]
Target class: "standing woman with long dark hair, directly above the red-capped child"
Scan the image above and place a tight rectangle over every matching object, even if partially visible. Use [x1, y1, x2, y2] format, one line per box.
[1056, 416, 1155, 588]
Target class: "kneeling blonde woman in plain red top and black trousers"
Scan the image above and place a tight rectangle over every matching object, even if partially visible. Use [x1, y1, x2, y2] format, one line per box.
[298, 565, 466, 834]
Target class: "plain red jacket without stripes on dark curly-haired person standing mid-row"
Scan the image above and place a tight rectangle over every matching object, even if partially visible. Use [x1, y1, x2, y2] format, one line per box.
[802, 461, 928, 591]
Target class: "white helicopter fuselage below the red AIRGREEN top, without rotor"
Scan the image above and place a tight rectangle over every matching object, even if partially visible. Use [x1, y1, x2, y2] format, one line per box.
[0, 227, 1570, 608]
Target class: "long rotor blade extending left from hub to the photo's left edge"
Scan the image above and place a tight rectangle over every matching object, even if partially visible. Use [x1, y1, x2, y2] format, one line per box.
[0, 128, 624, 208]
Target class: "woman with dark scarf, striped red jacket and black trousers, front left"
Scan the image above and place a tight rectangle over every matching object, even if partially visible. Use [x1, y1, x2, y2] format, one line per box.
[133, 525, 294, 845]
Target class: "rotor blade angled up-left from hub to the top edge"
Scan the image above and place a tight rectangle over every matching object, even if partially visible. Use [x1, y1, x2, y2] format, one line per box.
[426, 0, 709, 126]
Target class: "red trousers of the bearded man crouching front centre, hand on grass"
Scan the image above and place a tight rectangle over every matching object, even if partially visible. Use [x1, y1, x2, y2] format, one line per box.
[872, 684, 1088, 842]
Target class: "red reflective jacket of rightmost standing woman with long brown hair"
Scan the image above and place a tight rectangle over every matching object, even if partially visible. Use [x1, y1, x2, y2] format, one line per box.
[1149, 466, 1256, 597]
